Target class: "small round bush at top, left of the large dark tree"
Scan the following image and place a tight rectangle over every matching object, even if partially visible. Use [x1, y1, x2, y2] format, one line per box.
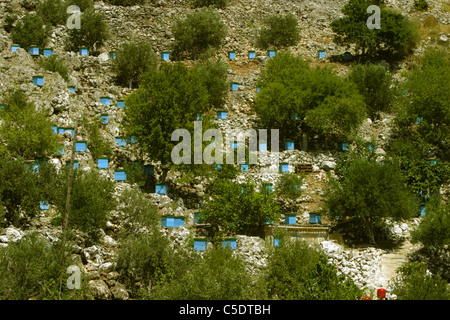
[256, 14, 300, 49]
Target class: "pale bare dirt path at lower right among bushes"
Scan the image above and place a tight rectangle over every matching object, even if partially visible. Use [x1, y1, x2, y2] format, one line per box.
[380, 240, 413, 288]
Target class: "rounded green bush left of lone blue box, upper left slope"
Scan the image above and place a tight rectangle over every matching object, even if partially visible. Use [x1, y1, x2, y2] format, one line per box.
[113, 42, 157, 88]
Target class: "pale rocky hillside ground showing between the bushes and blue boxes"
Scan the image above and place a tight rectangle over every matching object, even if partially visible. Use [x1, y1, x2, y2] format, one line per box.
[0, 0, 450, 299]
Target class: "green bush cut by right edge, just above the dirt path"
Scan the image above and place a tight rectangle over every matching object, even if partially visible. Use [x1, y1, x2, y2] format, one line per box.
[411, 196, 450, 249]
